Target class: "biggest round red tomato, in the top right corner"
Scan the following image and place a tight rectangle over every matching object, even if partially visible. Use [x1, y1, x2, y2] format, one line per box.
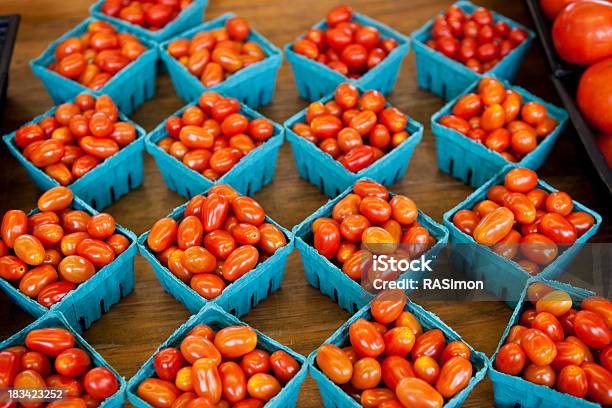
[552, 0, 612, 65]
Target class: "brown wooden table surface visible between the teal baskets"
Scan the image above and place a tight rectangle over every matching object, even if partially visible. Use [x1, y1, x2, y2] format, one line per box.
[0, 0, 612, 407]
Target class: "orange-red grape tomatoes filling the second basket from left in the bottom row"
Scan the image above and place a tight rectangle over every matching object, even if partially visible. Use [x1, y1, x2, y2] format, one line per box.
[137, 324, 300, 408]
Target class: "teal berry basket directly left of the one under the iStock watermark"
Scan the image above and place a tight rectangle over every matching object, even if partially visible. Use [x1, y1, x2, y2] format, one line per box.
[138, 190, 294, 317]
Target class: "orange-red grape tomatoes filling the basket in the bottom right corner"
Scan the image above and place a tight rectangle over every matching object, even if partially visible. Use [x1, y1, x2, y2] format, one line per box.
[495, 283, 612, 406]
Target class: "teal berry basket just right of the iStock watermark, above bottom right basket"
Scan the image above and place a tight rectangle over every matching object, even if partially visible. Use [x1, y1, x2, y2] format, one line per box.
[444, 165, 602, 308]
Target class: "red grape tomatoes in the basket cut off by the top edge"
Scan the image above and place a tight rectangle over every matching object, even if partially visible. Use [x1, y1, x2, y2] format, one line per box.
[100, 0, 192, 31]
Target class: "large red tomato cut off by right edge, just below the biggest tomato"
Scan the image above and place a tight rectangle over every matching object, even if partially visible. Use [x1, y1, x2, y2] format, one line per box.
[576, 58, 612, 133]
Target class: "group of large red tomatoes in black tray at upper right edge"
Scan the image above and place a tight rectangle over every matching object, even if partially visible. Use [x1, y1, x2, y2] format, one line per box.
[540, 0, 612, 169]
